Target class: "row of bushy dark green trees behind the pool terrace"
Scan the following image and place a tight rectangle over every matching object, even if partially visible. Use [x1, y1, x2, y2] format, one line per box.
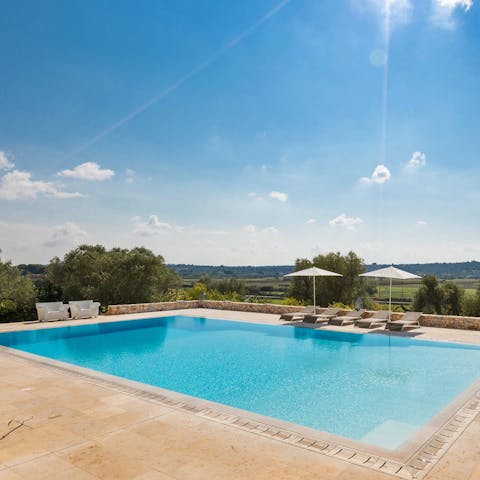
[0, 245, 480, 322]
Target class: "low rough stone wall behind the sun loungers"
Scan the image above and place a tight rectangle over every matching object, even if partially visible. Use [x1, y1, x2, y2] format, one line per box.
[107, 300, 480, 330]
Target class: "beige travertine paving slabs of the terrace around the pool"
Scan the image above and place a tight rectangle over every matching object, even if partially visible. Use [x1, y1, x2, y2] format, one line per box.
[0, 309, 480, 480]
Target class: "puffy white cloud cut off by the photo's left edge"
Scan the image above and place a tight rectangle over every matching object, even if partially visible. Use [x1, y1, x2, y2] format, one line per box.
[0, 170, 83, 200]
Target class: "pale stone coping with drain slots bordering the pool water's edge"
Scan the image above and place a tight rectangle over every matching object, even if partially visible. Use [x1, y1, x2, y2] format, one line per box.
[0, 309, 480, 479]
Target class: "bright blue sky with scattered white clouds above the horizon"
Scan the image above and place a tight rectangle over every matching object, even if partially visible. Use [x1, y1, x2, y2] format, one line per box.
[0, 0, 480, 265]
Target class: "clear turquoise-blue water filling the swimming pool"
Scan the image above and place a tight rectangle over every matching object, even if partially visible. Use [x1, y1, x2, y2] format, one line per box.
[0, 316, 480, 449]
